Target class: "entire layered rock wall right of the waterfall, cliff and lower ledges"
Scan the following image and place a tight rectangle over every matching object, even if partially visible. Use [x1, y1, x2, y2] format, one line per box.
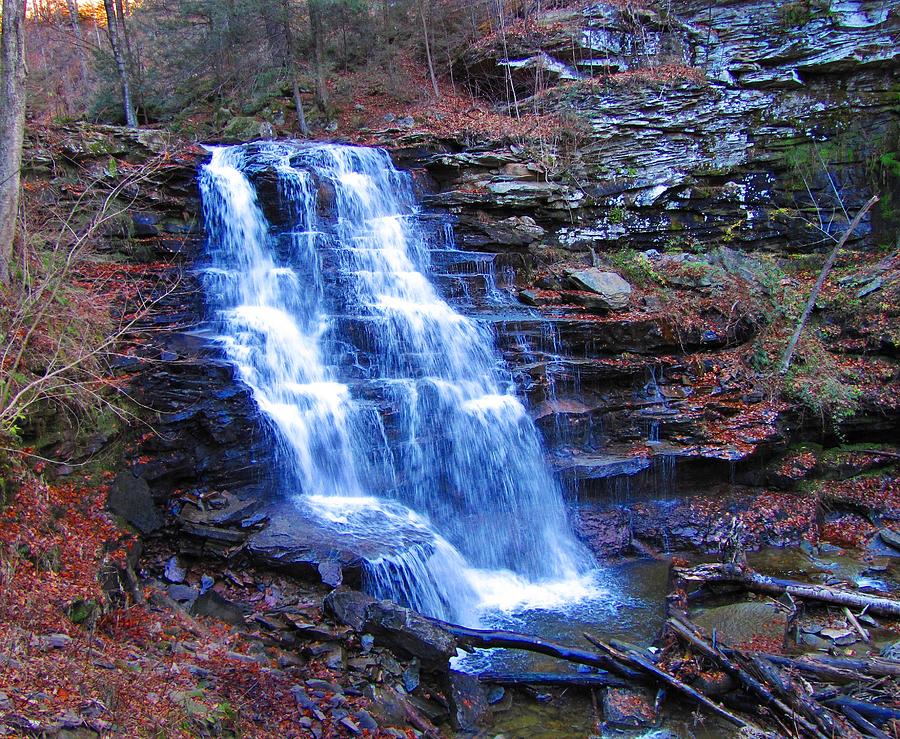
[388, 0, 900, 554]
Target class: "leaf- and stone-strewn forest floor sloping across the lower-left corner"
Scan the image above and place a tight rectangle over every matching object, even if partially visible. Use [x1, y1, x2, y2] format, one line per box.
[0, 468, 411, 739]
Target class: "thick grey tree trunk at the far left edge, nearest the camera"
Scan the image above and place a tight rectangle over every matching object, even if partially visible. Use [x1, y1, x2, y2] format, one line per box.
[0, 0, 26, 284]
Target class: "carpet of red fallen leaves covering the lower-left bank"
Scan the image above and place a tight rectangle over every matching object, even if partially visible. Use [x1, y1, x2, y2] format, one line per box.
[0, 472, 388, 739]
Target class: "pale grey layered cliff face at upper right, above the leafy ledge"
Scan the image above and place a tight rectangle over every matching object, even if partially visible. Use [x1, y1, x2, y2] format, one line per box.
[428, 0, 900, 251]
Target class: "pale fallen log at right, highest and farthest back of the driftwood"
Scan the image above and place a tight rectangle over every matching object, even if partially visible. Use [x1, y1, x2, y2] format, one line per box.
[677, 564, 900, 619]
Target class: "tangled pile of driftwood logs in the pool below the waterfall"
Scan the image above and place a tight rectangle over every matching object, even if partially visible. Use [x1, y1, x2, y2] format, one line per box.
[429, 580, 900, 739]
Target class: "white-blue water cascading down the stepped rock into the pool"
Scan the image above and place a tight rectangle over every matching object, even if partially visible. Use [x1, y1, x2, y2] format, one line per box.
[201, 143, 591, 621]
